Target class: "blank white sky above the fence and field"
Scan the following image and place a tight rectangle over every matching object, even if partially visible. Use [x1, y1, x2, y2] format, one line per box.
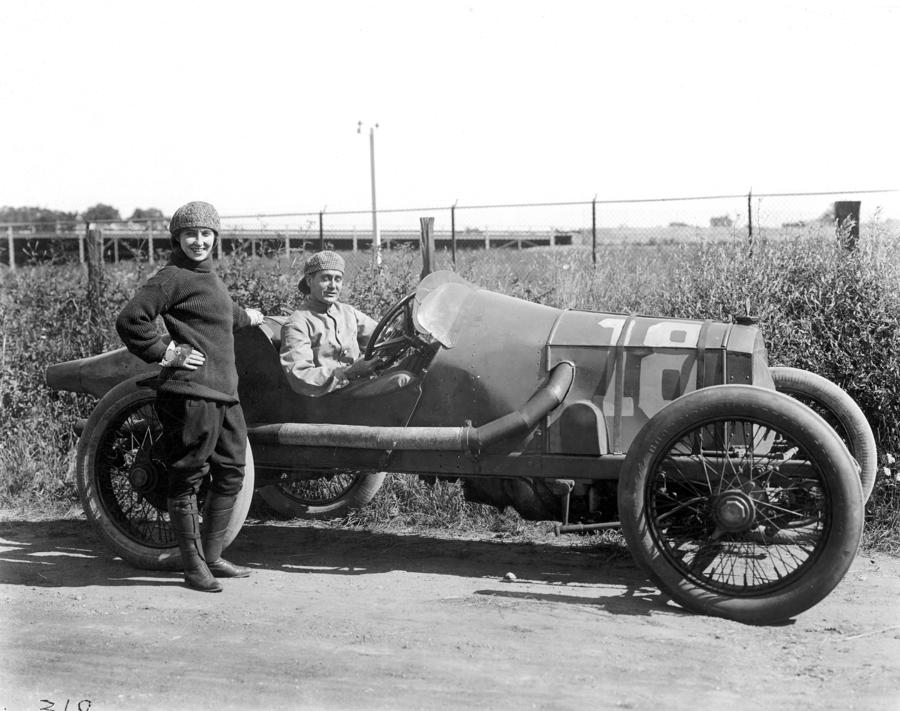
[0, 0, 900, 228]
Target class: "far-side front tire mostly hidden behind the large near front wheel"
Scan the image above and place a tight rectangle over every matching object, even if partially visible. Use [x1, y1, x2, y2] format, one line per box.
[769, 367, 878, 501]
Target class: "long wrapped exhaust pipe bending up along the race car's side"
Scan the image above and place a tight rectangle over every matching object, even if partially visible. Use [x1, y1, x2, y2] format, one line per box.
[248, 361, 575, 454]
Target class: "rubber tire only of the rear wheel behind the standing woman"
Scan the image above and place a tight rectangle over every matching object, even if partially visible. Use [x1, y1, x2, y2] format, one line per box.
[75, 376, 254, 570]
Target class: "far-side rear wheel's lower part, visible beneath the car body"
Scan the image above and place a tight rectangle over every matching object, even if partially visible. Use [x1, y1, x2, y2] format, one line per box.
[259, 469, 385, 518]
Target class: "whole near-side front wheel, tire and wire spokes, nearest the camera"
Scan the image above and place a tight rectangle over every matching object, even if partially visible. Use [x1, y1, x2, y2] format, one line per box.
[618, 385, 863, 624]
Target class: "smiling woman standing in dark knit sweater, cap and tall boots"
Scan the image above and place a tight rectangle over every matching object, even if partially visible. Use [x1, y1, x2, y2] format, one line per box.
[116, 202, 263, 592]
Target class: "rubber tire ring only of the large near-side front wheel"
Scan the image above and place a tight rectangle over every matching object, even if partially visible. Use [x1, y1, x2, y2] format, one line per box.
[618, 385, 863, 624]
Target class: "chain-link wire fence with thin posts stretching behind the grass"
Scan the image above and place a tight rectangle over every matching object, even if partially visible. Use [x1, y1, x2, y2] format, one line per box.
[0, 190, 900, 268]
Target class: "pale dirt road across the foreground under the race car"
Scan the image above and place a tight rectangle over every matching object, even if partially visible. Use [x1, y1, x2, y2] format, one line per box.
[0, 520, 900, 711]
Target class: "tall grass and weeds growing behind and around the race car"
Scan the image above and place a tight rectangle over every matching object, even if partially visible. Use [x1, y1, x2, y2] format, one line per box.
[0, 222, 900, 554]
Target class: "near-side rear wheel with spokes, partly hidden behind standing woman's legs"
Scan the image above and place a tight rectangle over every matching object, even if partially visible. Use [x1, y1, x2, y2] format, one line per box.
[75, 381, 254, 570]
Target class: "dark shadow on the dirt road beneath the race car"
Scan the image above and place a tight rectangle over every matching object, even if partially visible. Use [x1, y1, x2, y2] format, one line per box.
[0, 520, 652, 587]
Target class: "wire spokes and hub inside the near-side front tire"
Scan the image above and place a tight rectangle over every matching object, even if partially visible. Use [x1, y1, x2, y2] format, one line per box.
[646, 419, 831, 596]
